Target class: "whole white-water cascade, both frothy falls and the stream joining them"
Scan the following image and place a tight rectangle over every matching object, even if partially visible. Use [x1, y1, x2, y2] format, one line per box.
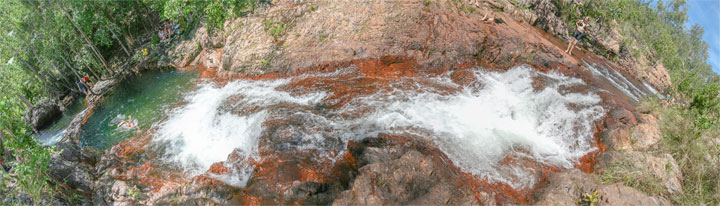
[156, 66, 603, 188]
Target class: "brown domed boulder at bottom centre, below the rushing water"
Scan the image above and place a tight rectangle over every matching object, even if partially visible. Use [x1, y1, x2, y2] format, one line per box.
[333, 150, 479, 205]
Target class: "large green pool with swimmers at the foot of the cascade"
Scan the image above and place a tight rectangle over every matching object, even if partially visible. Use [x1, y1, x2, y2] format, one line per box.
[81, 69, 197, 149]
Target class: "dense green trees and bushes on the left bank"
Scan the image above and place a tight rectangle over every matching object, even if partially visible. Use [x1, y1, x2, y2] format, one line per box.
[0, 0, 261, 204]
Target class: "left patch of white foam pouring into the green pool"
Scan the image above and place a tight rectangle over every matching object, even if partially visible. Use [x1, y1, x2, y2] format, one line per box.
[154, 80, 330, 186]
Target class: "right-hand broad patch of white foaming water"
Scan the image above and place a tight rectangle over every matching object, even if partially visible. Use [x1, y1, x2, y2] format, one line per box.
[346, 67, 602, 188]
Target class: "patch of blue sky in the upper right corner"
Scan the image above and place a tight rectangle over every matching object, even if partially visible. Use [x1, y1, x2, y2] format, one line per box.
[687, 0, 720, 73]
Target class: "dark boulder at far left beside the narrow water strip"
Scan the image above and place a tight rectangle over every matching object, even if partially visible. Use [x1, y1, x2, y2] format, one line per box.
[25, 99, 62, 130]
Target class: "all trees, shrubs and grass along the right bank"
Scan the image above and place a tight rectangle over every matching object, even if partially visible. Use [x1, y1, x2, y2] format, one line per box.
[552, 0, 720, 205]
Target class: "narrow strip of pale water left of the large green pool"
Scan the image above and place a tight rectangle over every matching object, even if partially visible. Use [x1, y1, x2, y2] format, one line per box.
[38, 98, 85, 145]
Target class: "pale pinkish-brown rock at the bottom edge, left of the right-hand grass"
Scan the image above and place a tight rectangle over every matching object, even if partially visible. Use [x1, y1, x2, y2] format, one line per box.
[535, 169, 671, 205]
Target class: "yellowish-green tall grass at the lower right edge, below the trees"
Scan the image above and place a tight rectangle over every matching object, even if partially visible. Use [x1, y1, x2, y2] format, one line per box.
[638, 100, 720, 205]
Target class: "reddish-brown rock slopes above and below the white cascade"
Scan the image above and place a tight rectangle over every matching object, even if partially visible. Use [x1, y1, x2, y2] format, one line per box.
[33, 1, 677, 205]
